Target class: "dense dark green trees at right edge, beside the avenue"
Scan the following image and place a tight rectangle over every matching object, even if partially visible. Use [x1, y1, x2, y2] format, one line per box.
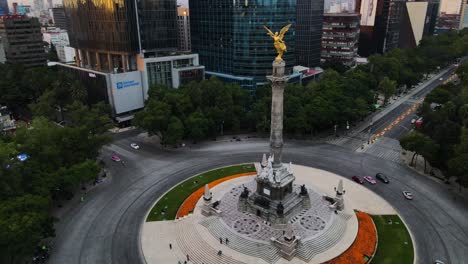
[400, 63, 468, 186]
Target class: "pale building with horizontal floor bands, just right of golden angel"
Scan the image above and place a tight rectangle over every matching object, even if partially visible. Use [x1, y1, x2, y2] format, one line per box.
[322, 13, 361, 66]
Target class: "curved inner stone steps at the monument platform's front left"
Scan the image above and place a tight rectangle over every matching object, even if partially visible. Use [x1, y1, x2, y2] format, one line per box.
[201, 217, 281, 263]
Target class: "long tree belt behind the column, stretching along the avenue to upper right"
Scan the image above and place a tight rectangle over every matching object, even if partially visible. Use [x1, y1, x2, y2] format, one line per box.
[135, 31, 468, 144]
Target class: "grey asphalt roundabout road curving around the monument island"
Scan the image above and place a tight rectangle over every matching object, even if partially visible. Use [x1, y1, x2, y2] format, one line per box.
[48, 137, 468, 263]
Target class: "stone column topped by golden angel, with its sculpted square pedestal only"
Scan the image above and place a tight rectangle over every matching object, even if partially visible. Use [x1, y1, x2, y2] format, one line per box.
[239, 24, 310, 225]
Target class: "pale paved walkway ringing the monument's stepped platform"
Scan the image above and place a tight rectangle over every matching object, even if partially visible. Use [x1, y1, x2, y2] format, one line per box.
[141, 165, 396, 264]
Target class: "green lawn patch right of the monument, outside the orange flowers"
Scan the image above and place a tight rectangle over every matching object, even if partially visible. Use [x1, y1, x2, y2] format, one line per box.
[372, 215, 414, 264]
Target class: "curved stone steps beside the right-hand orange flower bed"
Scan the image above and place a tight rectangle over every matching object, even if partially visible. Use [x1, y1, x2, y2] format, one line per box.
[296, 213, 351, 262]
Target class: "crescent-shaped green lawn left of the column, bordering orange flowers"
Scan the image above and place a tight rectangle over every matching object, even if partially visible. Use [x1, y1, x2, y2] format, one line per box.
[146, 164, 255, 222]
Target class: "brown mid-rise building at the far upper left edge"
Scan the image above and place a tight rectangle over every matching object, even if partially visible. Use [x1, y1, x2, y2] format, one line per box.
[0, 15, 47, 67]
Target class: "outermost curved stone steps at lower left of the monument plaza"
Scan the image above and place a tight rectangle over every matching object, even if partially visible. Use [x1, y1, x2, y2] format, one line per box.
[176, 218, 244, 264]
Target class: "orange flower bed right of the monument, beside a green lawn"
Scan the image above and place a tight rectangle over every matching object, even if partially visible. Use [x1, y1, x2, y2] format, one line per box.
[325, 212, 377, 264]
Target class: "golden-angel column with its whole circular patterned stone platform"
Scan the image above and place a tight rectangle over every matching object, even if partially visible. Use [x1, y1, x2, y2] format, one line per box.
[201, 25, 350, 263]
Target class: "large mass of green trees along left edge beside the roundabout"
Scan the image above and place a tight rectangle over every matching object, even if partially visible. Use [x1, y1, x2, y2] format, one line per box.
[0, 64, 112, 263]
